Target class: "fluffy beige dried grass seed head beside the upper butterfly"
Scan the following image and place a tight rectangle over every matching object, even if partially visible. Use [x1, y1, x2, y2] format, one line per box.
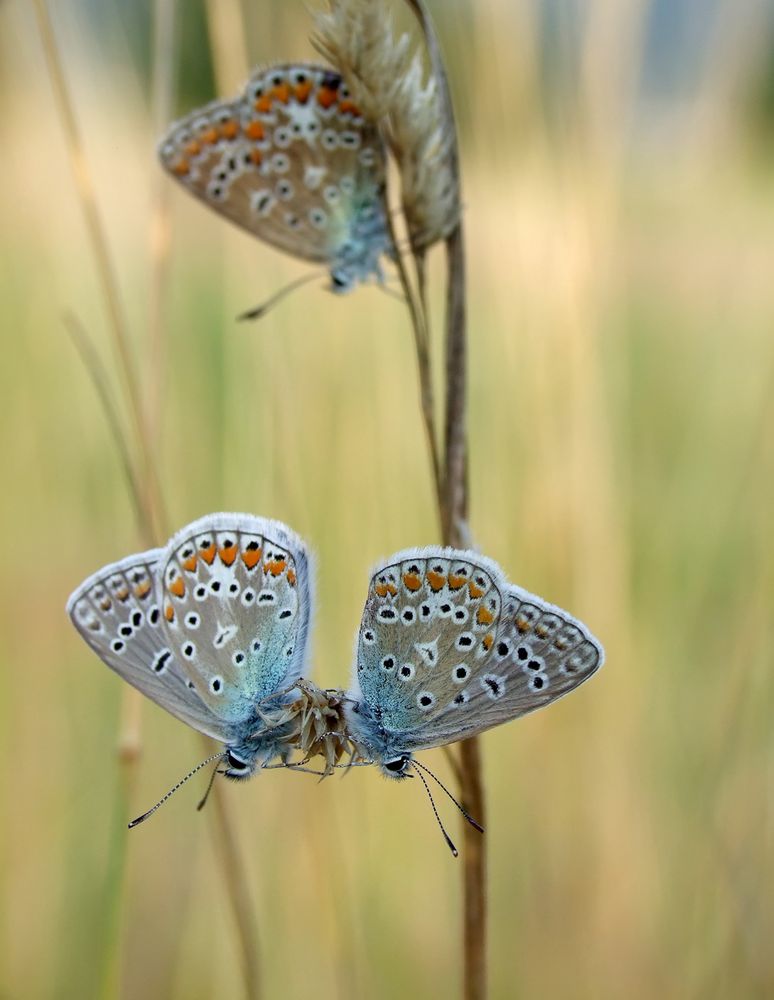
[312, 0, 459, 249]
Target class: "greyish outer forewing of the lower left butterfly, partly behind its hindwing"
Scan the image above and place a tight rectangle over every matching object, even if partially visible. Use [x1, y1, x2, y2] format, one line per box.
[67, 549, 227, 742]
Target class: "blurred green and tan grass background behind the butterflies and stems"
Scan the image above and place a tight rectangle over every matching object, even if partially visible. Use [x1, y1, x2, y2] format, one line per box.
[0, 0, 774, 1000]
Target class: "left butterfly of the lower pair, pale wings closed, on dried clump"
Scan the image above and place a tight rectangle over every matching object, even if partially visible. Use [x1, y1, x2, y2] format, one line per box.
[67, 514, 342, 815]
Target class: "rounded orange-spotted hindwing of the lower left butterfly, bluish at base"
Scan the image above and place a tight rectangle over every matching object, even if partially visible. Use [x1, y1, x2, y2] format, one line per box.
[156, 514, 311, 727]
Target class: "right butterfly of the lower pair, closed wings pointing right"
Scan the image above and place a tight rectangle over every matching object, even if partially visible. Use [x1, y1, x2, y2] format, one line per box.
[344, 547, 604, 778]
